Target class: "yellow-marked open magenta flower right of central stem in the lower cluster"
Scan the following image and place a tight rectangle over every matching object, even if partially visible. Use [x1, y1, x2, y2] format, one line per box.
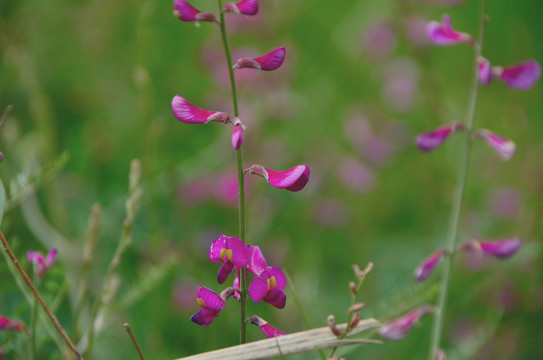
[249, 266, 287, 309]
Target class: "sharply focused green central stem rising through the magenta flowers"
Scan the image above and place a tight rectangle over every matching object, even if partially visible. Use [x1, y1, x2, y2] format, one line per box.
[217, 0, 247, 344]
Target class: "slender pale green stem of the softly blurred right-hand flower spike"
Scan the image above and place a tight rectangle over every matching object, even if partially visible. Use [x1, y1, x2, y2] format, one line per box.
[428, 0, 486, 360]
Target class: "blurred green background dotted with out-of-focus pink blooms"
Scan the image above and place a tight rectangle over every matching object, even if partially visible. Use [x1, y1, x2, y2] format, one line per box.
[0, 0, 543, 360]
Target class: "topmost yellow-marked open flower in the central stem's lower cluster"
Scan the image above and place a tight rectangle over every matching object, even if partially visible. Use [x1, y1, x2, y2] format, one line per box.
[209, 235, 249, 284]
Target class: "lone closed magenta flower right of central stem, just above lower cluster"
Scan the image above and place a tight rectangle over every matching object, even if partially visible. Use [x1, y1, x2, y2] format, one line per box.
[245, 165, 310, 192]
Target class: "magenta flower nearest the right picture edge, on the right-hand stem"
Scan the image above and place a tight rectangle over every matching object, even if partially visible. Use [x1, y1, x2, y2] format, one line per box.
[493, 60, 541, 90]
